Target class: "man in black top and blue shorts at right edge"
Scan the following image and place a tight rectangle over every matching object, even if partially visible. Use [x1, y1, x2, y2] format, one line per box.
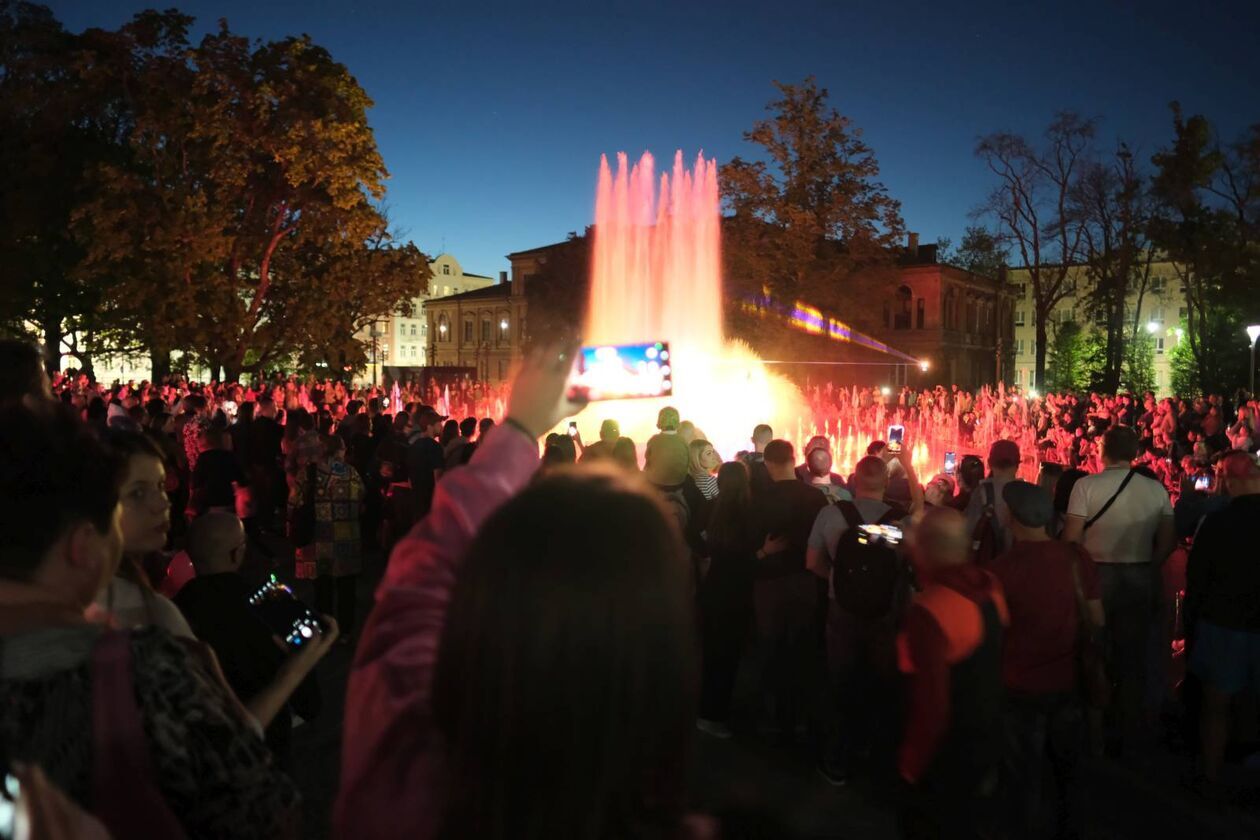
[1184, 452, 1260, 795]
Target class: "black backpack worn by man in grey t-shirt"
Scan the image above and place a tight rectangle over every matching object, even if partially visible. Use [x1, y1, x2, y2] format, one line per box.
[832, 501, 906, 620]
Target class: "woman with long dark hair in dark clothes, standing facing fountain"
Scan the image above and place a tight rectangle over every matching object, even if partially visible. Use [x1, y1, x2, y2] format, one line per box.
[697, 461, 788, 738]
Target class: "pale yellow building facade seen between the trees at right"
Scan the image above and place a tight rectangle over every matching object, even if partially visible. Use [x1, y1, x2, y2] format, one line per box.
[1007, 262, 1186, 397]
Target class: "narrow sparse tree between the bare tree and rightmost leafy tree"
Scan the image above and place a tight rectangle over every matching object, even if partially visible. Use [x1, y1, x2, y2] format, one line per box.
[1072, 142, 1155, 392]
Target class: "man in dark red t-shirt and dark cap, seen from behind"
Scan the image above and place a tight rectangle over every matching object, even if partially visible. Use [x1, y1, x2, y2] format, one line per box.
[992, 481, 1103, 837]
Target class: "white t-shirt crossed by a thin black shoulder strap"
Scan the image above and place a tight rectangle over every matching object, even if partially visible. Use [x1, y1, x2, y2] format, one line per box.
[1067, 466, 1173, 563]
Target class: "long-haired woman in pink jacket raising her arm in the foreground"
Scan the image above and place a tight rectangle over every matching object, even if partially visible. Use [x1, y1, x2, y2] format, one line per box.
[334, 349, 697, 840]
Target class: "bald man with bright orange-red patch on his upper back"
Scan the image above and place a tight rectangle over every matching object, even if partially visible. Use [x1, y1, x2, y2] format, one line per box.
[897, 508, 1007, 837]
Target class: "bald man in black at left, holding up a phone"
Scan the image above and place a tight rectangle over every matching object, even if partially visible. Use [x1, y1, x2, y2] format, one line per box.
[175, 513, 327, 767]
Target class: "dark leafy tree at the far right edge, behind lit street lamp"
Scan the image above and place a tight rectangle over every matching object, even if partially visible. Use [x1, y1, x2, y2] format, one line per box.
[1152, 102, 1260, 393]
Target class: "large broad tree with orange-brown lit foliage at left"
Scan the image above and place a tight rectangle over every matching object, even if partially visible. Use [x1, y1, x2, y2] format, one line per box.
[77, 13, 413, 378]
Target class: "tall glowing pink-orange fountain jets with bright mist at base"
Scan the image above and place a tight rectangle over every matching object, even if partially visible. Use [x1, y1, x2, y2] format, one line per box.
[582, 151, 801, 457]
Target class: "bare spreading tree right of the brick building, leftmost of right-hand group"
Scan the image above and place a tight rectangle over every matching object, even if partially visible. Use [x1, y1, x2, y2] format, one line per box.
[975, 112, 1094, 389]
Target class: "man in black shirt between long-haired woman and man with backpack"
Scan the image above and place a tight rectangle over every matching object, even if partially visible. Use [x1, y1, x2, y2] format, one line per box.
[752, 441, 827, 735]
